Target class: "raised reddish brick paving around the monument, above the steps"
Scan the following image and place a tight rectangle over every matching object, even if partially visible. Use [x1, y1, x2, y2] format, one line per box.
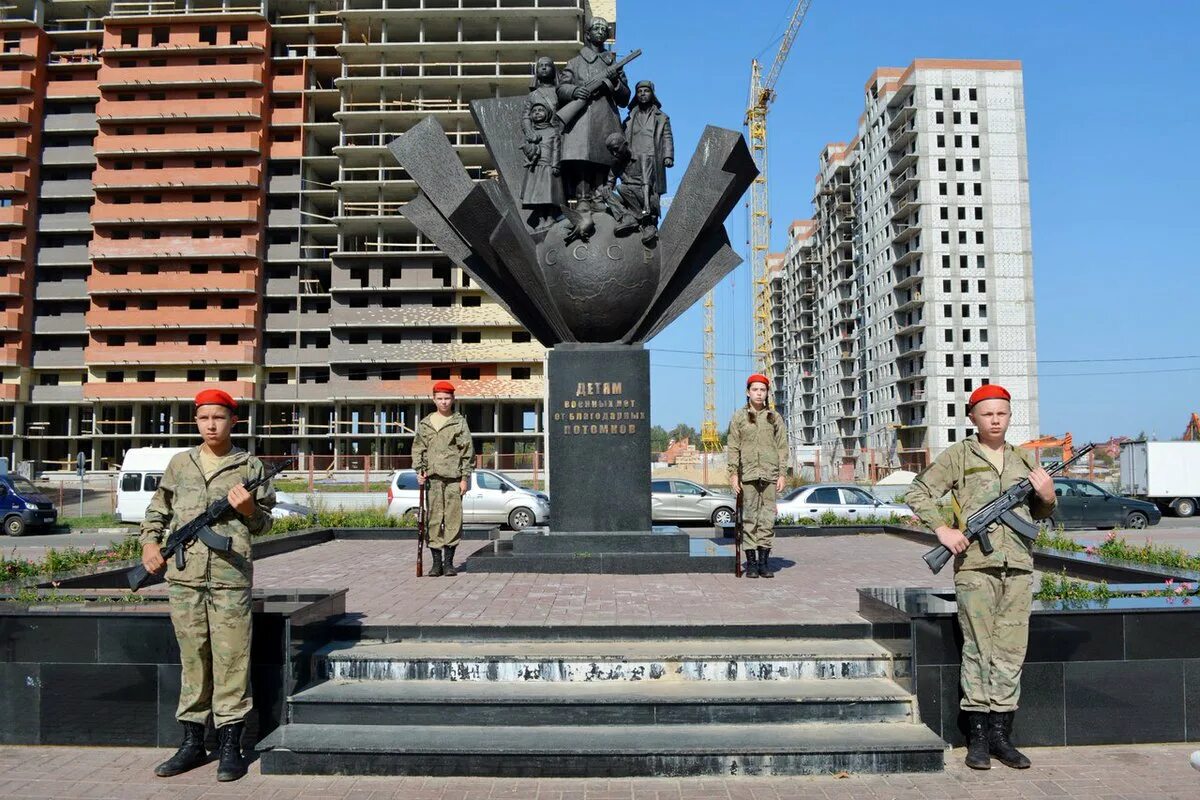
[254, 534, 953, 625]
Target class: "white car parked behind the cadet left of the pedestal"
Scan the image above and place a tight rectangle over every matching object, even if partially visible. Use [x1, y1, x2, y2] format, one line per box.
[388, 469, 550, 530]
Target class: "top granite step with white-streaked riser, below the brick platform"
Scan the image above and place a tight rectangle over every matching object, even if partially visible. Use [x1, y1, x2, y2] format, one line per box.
[313, 639, 910, 682]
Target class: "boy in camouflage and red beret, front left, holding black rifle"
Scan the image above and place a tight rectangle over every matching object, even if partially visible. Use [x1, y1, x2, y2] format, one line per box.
[142, 389, 275, 781]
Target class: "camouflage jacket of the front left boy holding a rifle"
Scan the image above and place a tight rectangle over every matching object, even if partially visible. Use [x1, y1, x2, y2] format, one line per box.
[142, 447, 275, 589]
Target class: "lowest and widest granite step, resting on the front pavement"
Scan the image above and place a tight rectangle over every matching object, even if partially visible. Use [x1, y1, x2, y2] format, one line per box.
[258, 722, 946, 777]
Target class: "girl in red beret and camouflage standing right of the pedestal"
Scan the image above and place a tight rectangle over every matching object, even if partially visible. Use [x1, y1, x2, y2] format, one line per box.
[726, 374, 787, 578]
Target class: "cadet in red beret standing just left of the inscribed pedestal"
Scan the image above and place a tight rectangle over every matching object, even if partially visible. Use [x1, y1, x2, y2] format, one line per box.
[413, 380, 475, 578]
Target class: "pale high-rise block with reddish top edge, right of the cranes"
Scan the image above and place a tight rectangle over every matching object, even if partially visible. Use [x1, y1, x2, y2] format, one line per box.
[775, 59, 1038, 479]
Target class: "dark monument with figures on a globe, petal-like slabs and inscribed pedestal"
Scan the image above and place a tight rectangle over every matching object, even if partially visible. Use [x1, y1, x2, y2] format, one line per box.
[389, 18, 758, 572]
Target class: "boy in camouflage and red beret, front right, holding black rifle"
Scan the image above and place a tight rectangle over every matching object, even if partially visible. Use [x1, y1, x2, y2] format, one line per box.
[905, 384, 1055, 769]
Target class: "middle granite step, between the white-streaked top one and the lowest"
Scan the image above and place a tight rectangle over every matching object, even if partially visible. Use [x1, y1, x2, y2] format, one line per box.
[288, 678, 916, 726]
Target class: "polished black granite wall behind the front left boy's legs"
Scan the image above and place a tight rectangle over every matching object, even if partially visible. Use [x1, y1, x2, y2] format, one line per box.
[0, 590, 344, 747]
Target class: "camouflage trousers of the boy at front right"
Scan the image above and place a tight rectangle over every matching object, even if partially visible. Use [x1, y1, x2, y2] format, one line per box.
[954, 567, 1033, 711]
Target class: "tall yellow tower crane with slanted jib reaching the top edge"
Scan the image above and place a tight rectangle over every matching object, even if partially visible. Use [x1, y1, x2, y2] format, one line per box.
[745, 0, 812, 377]
